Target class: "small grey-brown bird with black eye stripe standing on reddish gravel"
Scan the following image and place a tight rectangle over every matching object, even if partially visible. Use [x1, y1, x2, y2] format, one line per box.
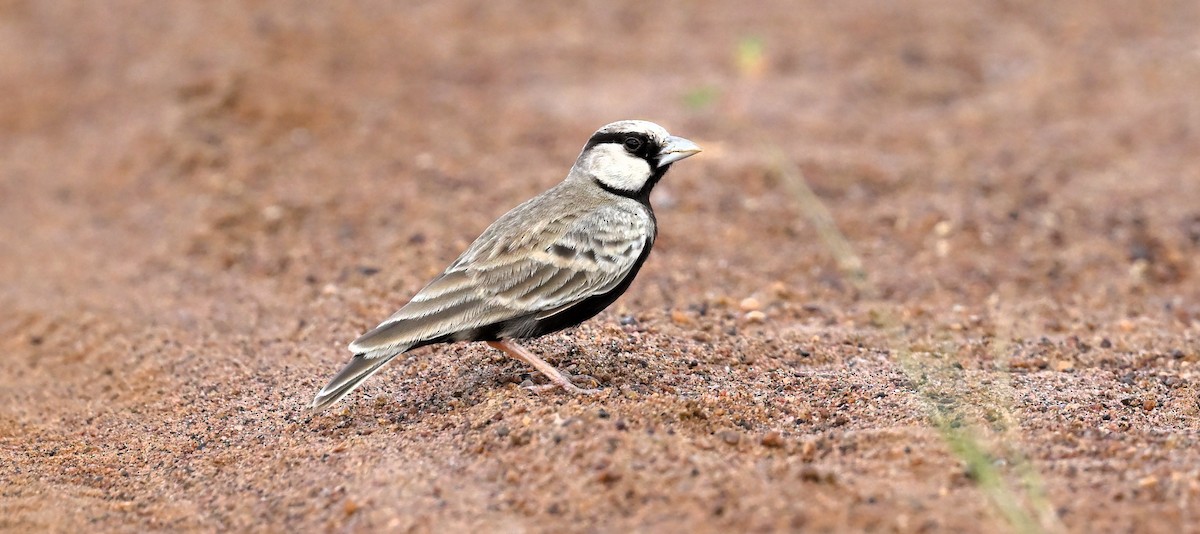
[310, 120, 701, 414]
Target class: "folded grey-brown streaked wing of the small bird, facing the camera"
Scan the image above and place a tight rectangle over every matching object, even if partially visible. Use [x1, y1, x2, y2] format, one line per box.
[350, 205, 654, 358]
